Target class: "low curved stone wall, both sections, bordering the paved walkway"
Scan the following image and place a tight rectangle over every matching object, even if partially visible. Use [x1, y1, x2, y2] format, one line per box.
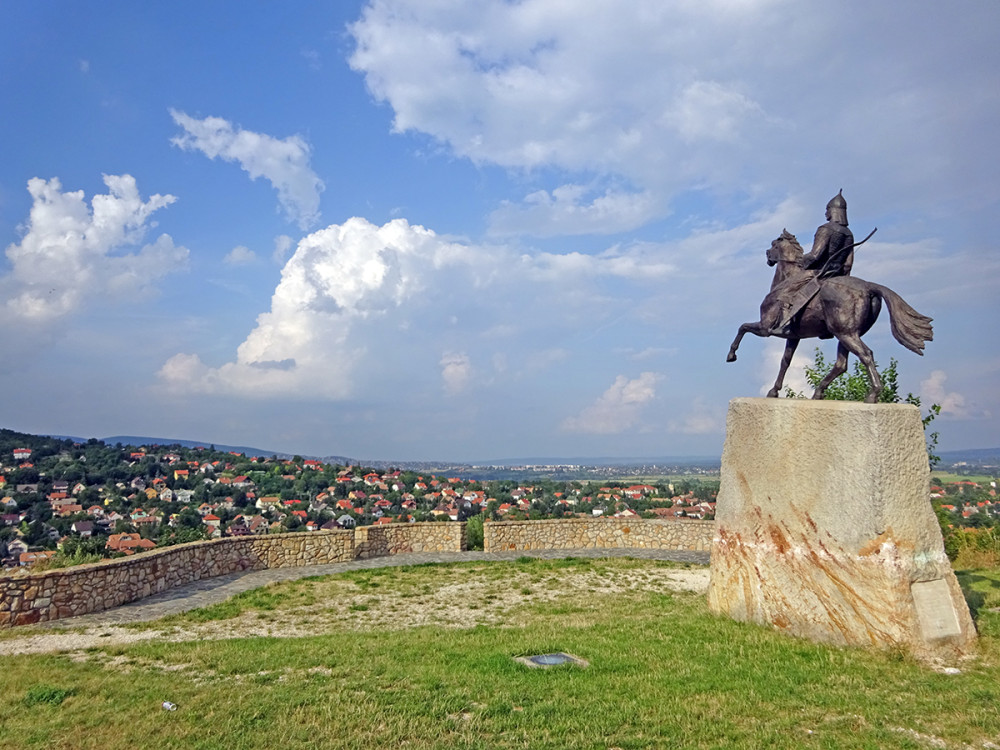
[0, 518, 715, 628]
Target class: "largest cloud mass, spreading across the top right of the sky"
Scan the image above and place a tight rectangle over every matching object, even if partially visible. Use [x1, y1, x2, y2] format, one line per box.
[350, 0, 1000, 235]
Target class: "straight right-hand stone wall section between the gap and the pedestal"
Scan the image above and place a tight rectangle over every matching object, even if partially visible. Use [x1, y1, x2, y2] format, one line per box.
[483, 517, 715, 552]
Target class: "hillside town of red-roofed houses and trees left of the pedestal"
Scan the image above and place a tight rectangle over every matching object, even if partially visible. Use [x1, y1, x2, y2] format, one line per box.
[0, 431, 717, 568]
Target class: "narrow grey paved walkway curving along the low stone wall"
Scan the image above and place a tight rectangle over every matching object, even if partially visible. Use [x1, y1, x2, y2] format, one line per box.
[34, 549, 709, 628]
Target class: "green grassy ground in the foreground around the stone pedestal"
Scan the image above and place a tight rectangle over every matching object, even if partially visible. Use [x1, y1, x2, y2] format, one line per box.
[0, 558, 1000, 750]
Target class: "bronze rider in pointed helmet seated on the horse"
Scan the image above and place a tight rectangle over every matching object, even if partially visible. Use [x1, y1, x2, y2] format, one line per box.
[771, 189, 860, 336]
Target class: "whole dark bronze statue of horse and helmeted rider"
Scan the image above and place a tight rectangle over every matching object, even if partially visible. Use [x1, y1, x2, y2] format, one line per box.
[726, 191, 934, 404]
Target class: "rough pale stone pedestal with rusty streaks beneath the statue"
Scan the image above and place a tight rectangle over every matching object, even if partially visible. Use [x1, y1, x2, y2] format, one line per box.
[708, 398, 976, 657]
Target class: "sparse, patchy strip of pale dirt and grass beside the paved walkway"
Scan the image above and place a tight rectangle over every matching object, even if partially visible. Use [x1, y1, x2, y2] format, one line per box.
[0, 560, 709, 655]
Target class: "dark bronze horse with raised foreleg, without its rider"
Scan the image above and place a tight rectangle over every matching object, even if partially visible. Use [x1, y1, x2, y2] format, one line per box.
[726, 229, 934, 404]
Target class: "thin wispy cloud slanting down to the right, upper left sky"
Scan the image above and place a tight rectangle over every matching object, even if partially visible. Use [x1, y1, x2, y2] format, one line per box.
[170, 109, 324, 229]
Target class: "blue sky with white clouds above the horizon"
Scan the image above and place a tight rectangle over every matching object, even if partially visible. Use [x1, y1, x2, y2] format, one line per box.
[0, 0, 1000, 461]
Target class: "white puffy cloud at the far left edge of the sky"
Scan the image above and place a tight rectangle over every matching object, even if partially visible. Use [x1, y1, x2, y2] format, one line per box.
[0, 175, 188, 324]
